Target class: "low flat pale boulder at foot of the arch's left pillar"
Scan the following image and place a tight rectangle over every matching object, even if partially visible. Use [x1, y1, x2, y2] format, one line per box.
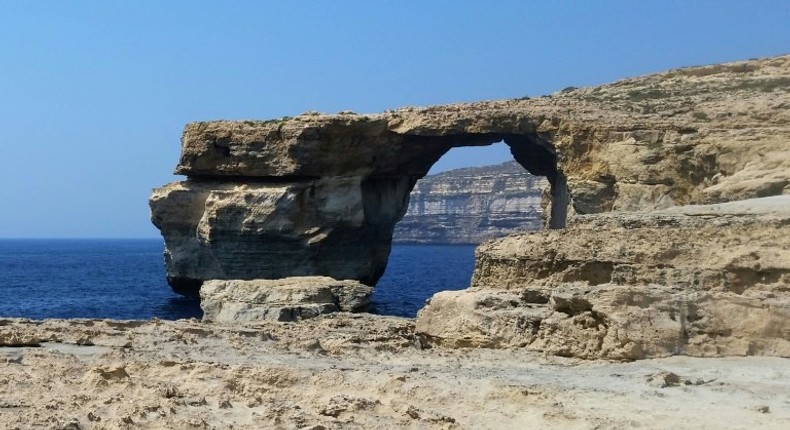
[200, 276, 373, 322]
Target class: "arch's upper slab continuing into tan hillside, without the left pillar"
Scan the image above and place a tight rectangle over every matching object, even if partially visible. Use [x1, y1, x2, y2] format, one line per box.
[170, 56, 790, 213]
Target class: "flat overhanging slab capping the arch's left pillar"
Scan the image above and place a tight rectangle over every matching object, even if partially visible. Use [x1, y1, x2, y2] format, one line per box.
[176, 114, 450, 178]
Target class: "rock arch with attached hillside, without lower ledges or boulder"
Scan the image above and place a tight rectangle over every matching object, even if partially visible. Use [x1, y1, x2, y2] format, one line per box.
[150, 56, 790, 304]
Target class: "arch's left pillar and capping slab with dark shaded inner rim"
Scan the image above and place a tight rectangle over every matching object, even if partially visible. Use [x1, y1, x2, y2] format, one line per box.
[150, 112, 570, 296]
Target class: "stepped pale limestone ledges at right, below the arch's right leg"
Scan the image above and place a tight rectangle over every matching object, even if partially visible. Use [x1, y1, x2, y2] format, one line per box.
[417, 196, 790, 359]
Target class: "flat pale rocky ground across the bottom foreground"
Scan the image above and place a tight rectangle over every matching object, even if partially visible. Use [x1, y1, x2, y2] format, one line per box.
[0, 313, 790, 430]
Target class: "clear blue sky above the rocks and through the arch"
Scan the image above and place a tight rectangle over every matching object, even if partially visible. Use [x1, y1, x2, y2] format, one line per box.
[0, 0, 790, 237]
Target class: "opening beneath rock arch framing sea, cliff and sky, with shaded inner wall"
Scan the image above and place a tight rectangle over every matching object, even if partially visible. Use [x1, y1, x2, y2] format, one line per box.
[371, 134, 568, 317]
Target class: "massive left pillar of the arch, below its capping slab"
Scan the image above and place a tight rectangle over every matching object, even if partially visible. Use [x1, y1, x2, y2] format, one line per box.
[151, 177, 410, 296]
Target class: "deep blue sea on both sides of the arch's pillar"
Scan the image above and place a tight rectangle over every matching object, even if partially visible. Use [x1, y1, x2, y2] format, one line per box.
[0, 239, 475, 319]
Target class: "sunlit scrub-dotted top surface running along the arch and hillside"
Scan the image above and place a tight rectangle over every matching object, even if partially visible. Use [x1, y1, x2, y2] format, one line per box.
[184, 55, 790, 138]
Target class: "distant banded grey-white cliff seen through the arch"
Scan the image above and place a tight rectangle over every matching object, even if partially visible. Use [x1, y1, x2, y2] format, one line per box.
[393, 161, 546, 244]
